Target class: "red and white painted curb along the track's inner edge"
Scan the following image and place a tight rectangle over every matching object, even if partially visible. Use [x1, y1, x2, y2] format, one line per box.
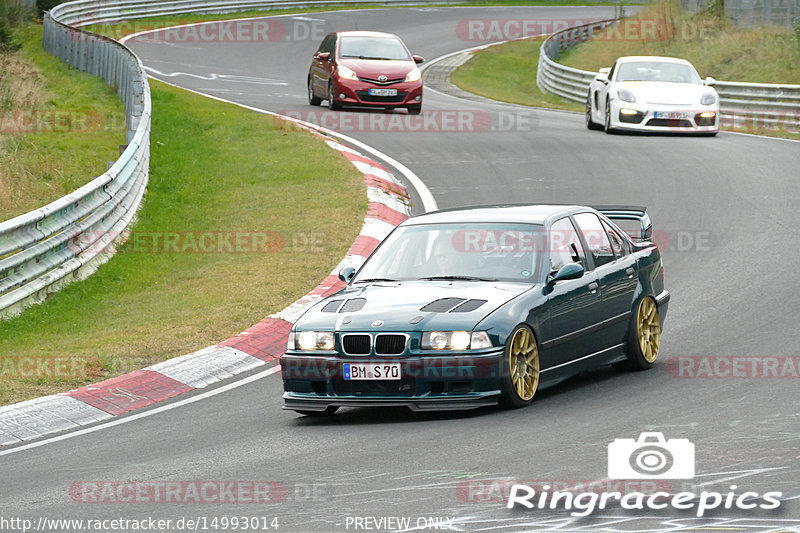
[0, 130, 410, 446]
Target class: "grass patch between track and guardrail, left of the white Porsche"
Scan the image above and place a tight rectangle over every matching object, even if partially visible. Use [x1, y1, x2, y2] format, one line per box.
[450, 37, 583, 111]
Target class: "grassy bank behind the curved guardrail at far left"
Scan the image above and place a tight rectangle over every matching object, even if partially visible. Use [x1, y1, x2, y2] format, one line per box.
[0, 24, 125, 220]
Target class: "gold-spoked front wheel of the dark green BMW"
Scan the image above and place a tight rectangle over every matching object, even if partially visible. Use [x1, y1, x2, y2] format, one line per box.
[500, 325, 539, 408]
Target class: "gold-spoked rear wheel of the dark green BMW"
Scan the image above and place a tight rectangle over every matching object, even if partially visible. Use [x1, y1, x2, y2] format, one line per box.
[613, 296, 661, 370]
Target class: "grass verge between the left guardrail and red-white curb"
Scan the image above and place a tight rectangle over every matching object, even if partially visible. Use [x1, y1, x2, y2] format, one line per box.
[0, 81, 366, 405]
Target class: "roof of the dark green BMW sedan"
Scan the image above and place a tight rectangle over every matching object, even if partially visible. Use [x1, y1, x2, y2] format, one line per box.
[402, 204, 594, 226]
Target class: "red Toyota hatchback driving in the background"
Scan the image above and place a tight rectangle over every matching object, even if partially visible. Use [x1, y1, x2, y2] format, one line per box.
[308, 31, 424, 115]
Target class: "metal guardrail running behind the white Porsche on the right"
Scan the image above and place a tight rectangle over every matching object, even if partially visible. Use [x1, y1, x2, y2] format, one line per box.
[536, 20, 800, 131]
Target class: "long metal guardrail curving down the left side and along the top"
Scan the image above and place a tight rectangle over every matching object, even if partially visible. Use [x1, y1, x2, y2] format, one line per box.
[0, 0, 457, 318]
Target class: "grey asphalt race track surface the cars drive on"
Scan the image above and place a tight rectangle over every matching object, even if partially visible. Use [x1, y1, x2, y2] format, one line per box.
[0, 7, 800, 532]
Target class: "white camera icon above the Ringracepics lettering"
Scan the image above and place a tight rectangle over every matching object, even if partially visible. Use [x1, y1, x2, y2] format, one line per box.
[608, 432, 694, 479]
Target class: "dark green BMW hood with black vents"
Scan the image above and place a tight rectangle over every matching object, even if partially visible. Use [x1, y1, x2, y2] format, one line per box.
[295, 281, 532, 332]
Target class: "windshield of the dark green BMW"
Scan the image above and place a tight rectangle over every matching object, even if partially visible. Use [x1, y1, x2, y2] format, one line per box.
[353, 223, 544, 283]
